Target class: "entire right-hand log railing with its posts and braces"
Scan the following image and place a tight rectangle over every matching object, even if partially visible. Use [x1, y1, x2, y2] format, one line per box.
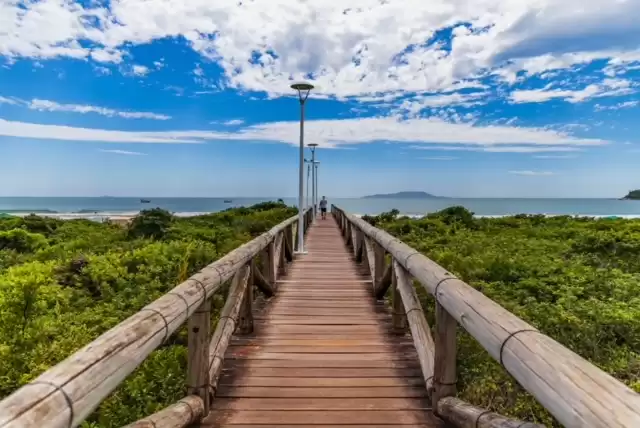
[332, 206, 640, 428]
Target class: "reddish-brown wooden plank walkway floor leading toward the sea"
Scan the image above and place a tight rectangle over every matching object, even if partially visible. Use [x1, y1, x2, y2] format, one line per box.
[201, 215, 442, 428]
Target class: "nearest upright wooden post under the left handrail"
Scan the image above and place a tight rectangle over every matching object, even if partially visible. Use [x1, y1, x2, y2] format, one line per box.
[187, 299, 211, 416]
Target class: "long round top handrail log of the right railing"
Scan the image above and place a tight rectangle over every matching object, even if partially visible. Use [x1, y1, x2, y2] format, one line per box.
[332, 207, 640, 428]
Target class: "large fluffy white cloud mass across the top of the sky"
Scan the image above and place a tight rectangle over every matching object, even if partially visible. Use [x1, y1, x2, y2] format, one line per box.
[0, 0, 640, 101]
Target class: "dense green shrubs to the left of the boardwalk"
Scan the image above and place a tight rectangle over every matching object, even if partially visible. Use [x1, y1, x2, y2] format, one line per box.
[0, 203, 296, 427]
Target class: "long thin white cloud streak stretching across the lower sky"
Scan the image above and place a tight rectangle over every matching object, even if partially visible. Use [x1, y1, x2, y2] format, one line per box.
[0, 117, 607, 152]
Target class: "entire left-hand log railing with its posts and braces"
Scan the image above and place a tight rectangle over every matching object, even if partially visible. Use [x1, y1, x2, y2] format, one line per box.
[0, 210, 312, 428]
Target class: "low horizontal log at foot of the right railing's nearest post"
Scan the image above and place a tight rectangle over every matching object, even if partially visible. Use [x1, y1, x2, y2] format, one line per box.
[437, 397, 544, 428]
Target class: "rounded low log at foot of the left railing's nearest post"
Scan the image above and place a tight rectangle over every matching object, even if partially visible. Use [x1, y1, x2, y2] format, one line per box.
[123, 395, 205, 428]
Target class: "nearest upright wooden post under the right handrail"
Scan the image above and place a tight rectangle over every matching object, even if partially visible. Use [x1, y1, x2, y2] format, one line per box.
[431, 302, 458, 410]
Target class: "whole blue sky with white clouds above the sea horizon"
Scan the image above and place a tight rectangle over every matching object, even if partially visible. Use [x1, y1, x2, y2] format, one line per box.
[0, 0, 640, 197]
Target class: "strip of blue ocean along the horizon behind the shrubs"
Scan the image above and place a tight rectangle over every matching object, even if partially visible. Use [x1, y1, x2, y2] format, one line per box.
[0, 197, 640, 220]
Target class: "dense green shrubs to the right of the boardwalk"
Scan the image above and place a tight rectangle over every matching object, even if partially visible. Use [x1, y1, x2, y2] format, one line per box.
[364, 207, 640, 426]
